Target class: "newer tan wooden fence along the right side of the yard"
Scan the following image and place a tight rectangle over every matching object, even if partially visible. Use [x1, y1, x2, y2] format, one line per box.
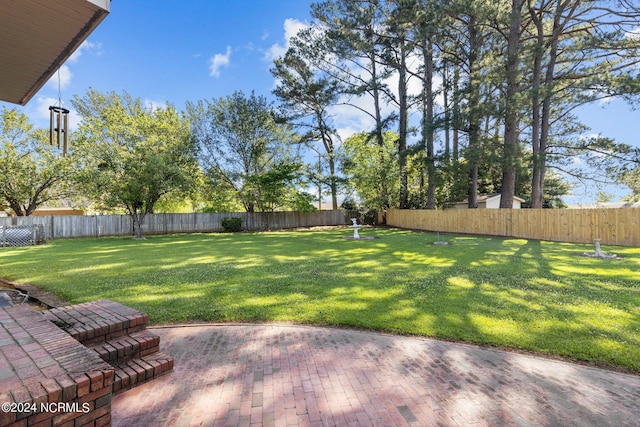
[387, 208, 640, 246]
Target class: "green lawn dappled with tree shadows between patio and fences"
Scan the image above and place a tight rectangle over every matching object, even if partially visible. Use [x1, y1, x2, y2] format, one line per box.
[0, 229, 640, 373]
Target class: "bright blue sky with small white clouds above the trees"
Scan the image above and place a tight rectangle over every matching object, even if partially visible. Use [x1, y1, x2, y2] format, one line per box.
[0, 0, 640, 203]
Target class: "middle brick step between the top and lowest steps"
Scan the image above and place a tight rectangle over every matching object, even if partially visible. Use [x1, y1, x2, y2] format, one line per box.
[88, 330, 160, 366]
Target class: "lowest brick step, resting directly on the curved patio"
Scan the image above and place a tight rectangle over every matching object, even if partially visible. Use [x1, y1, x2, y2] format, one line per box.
[113, 352, 173, 394]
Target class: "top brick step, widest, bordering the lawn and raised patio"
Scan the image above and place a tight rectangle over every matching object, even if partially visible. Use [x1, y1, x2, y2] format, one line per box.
[44, 300, 149, 344]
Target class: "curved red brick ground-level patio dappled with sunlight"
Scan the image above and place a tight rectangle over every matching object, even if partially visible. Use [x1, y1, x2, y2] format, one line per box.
[112, 325, 640, 427]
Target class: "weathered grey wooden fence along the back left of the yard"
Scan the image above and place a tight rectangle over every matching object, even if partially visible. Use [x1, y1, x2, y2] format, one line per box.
[0, 210, 358, 240]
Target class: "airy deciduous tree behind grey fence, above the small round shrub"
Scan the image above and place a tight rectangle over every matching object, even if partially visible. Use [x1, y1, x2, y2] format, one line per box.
[187, 91, 301, 212]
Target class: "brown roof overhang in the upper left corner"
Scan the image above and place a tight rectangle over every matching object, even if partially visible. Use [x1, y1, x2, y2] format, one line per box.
[0, 0, 111, 105]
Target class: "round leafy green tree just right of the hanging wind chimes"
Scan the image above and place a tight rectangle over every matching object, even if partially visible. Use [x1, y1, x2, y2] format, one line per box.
[72, 90, 195, 238]
